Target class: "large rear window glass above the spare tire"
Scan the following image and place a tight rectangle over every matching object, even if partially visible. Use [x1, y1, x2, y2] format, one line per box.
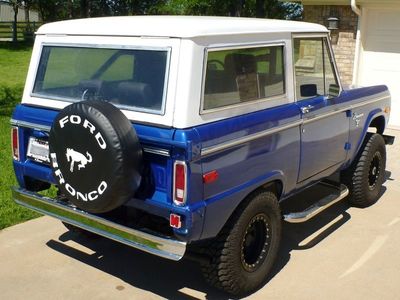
[33, 46, 169, 114]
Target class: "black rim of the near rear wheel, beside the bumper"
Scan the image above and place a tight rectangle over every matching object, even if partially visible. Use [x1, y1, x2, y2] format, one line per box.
[241, 214, 271, 272]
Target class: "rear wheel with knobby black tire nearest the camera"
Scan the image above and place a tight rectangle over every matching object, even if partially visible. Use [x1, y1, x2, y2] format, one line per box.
[201, 190, 282, 296]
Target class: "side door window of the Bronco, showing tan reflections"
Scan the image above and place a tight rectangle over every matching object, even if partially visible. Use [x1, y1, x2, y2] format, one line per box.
[293, 38, 339, 100]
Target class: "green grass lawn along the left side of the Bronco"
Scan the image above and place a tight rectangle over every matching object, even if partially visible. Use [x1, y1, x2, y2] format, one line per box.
[0, 43, 39, 229]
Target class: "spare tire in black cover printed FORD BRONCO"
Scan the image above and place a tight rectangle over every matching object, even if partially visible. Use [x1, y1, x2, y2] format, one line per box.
[49, 100, 142, 213]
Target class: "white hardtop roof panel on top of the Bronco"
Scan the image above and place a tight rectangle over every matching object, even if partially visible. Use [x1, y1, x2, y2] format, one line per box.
[37, 16, 328, 38]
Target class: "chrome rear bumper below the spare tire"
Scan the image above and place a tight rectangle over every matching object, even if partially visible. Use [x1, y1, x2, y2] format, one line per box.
[12, 187, 186, 260]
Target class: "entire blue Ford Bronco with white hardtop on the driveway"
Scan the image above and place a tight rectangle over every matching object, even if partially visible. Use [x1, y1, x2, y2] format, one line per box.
[11, 16, 394, 295]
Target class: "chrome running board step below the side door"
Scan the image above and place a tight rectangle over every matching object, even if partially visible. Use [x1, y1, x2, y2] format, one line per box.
[283, 184, 349, 223]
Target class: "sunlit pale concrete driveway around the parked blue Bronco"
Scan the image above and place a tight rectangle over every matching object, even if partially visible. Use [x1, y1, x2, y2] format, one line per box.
[0, 132, 400, 300]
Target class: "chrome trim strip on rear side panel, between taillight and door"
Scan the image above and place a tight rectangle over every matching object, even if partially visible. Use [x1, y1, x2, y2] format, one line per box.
[201, 120, 303, 156]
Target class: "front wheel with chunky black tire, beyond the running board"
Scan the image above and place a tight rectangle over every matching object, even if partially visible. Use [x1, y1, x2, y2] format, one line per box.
[342, 133, 386, 208]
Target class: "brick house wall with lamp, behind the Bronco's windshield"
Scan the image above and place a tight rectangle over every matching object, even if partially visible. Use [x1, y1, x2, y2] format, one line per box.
[304, 5, 358, 85]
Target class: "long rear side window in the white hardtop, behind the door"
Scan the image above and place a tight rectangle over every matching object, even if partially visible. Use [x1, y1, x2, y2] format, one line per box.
[203, 46, 285, 110]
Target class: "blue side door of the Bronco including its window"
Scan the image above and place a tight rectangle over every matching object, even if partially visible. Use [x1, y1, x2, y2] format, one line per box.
[293, 36, 349, 182]
